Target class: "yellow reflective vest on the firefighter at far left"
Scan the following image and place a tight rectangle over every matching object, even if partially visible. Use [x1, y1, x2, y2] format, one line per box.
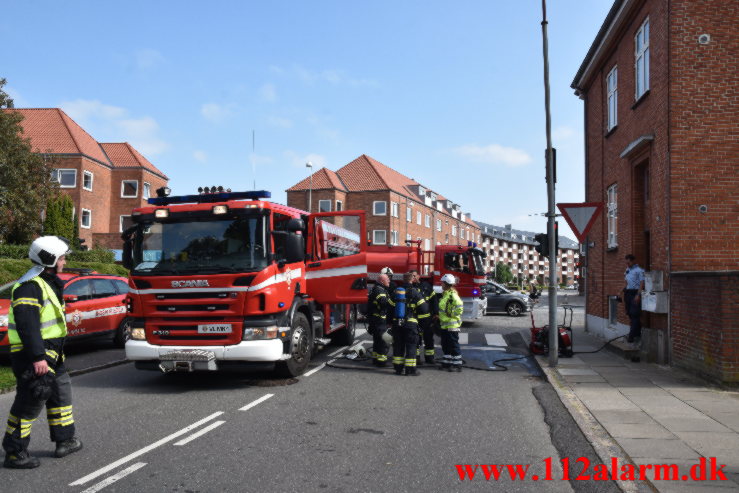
[8, 276, 67, 344]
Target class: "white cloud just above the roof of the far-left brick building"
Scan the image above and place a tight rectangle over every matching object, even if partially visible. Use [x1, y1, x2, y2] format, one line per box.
[59, 99, 169, 156]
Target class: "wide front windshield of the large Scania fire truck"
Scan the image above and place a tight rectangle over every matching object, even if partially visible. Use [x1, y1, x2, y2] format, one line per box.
[133, 215, 269, 275]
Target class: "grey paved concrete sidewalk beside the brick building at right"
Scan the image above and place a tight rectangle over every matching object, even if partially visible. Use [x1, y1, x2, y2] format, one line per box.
[538, 327, 739, 493]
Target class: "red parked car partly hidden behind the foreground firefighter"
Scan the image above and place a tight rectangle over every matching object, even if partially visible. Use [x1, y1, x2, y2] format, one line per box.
[0, 269, 129, 352]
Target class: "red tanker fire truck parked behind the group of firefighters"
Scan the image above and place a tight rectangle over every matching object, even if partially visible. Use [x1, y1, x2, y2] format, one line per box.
[367, 241, 487, 322]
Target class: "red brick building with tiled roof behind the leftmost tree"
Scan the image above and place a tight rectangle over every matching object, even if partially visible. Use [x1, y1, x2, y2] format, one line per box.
[4, 108, 168, 249]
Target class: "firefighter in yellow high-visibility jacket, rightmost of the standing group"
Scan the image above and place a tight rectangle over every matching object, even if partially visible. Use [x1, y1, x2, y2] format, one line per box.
[439, 274, 464, 371]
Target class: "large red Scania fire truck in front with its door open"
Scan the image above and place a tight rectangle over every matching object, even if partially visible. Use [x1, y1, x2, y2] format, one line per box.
[123, 187, 367, 376]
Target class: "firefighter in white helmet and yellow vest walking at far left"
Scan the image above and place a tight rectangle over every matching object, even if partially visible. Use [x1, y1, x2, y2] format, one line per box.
[3, 236, 82, 469]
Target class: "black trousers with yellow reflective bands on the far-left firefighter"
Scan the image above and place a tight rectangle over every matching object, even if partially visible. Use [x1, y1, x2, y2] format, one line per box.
[3, 356, 75, 454]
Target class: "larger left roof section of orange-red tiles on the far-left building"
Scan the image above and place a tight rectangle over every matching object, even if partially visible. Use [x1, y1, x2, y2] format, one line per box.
[3, 108, 111, 166]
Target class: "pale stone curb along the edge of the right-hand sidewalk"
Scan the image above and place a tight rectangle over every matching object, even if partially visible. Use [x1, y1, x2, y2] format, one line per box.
[534, 358, 659, 493]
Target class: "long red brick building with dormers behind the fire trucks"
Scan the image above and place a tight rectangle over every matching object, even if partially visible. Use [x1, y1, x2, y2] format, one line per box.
[286, 154, 482, 249]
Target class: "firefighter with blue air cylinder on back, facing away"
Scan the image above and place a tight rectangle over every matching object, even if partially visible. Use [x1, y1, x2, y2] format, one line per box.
[390, 272, 423, 376]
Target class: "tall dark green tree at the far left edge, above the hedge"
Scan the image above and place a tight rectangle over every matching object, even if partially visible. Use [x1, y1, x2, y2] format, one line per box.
[0, 78, 58, 244]
